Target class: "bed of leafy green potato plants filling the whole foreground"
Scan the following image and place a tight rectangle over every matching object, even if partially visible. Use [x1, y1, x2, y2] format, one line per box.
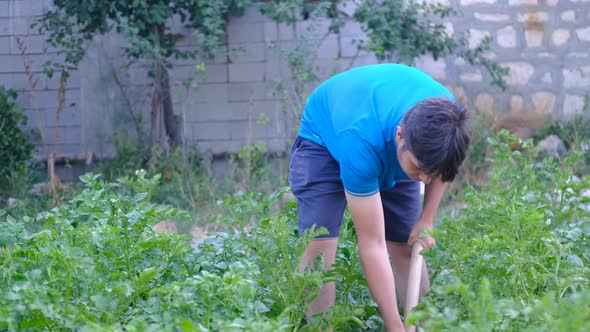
[0, 132, 590, 331]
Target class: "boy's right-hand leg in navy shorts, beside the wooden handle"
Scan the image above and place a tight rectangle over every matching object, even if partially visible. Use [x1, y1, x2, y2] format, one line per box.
[381, 180, 430, 306]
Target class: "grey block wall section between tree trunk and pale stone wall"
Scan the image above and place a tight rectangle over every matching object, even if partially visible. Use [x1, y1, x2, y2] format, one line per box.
[182, 9, 377, 154]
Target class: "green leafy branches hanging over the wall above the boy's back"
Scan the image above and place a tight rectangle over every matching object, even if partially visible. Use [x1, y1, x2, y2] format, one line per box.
[259, 0, 508, 90]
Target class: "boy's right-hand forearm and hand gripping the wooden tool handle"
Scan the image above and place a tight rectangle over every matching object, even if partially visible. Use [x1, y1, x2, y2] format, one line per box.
[408, 176, 449, 249]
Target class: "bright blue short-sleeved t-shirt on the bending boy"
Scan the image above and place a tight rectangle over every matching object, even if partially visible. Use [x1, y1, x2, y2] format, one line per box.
[299, 64, 455, 196]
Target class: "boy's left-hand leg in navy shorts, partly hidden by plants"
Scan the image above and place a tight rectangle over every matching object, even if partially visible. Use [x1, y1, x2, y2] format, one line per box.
[289, 138, 346, 319]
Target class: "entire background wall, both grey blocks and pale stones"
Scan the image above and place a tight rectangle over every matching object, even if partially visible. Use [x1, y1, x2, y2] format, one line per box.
[0, 0, 590, 158]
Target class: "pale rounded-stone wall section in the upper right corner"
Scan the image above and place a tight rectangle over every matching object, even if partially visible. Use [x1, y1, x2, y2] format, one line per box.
[444, 0, 590, 117]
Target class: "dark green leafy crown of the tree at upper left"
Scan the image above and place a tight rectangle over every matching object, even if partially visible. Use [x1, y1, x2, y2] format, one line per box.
[38, 0, 249, 78]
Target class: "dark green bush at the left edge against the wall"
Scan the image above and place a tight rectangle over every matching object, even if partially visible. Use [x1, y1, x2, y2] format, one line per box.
[0, 85, 33, 186]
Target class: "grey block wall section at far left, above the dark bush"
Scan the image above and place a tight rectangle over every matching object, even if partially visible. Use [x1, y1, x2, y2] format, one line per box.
[0, 0, 85, 156]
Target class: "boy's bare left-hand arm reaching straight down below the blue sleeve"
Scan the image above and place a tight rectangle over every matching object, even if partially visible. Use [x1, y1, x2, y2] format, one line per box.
[346, 193, 404, 332]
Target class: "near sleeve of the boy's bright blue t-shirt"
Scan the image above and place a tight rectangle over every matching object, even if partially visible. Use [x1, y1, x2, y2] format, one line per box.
[338, 130, 383, 197]
